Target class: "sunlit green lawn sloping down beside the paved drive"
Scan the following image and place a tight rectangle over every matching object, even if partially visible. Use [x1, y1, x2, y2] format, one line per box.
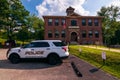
[69, 45, 120, 78]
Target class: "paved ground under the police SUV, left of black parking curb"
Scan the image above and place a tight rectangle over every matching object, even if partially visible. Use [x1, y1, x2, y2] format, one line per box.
[0, 49, 78, 80]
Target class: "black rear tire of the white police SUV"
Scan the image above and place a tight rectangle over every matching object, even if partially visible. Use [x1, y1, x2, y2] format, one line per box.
[47, 54, 61, 65]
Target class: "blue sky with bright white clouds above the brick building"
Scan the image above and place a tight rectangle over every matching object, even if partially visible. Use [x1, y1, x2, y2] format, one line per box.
[21, 0, 120, 17]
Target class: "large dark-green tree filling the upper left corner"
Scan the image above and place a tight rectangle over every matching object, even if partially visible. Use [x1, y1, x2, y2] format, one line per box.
[0, 0, 29, 37]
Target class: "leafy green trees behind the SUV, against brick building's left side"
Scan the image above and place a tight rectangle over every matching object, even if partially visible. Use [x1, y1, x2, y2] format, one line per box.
[16, 15, 44, 42]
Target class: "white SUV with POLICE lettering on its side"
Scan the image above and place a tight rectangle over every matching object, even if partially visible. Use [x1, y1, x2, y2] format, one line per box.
[7, 40, 69, 65]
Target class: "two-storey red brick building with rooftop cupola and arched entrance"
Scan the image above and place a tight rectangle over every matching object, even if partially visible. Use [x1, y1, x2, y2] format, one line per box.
[43, 7, 103, 44]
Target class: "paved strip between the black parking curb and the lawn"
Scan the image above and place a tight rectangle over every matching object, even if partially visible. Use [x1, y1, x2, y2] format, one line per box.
[69, 55, 120, 80]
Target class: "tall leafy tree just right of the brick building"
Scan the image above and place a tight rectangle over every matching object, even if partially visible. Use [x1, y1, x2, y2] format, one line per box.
[97, 5, 120, 45]
